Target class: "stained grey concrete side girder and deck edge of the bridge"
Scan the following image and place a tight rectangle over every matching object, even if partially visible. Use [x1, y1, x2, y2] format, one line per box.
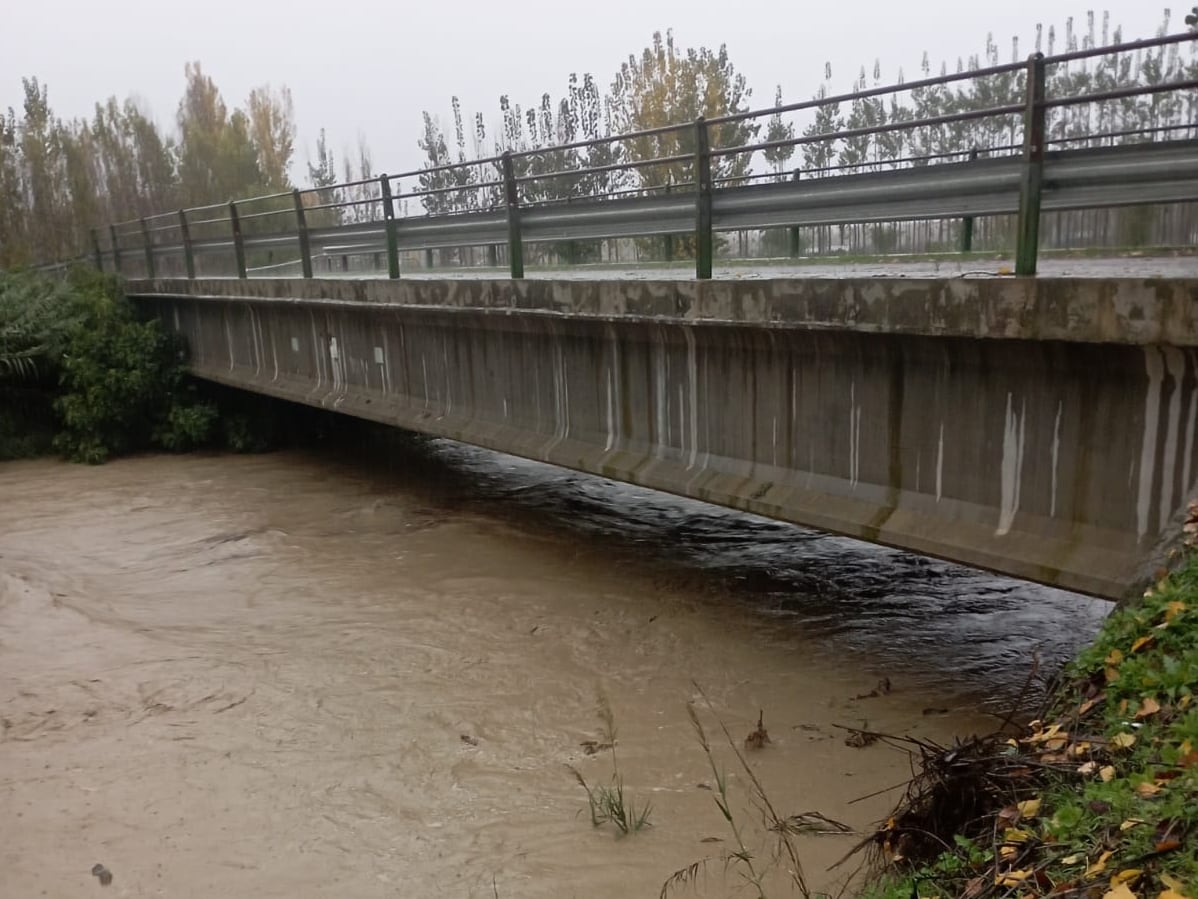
[128, 270, 1198, 599]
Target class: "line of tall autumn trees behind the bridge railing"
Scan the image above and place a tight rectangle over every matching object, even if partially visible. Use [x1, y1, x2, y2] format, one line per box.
[0, 12, 1198, 266]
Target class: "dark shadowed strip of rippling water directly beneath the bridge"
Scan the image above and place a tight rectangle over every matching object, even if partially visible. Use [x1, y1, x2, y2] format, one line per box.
[304, 418, 1113, 713]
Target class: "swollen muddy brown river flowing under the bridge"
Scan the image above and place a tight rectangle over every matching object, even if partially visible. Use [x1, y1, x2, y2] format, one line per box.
[0, 440, 1107, 899]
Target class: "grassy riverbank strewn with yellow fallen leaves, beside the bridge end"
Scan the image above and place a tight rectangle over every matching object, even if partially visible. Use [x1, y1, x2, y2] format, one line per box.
[870, 513, 1198, 899]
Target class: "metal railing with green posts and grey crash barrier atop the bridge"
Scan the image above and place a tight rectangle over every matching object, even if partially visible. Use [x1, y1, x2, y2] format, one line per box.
[63, 34, 1198, 278]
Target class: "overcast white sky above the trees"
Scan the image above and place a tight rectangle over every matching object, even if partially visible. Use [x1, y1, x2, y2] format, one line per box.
[0, 0, 1174, 175]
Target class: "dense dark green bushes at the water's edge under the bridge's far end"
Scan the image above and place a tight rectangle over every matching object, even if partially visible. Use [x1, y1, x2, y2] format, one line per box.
[0, 269, 297, 463]
